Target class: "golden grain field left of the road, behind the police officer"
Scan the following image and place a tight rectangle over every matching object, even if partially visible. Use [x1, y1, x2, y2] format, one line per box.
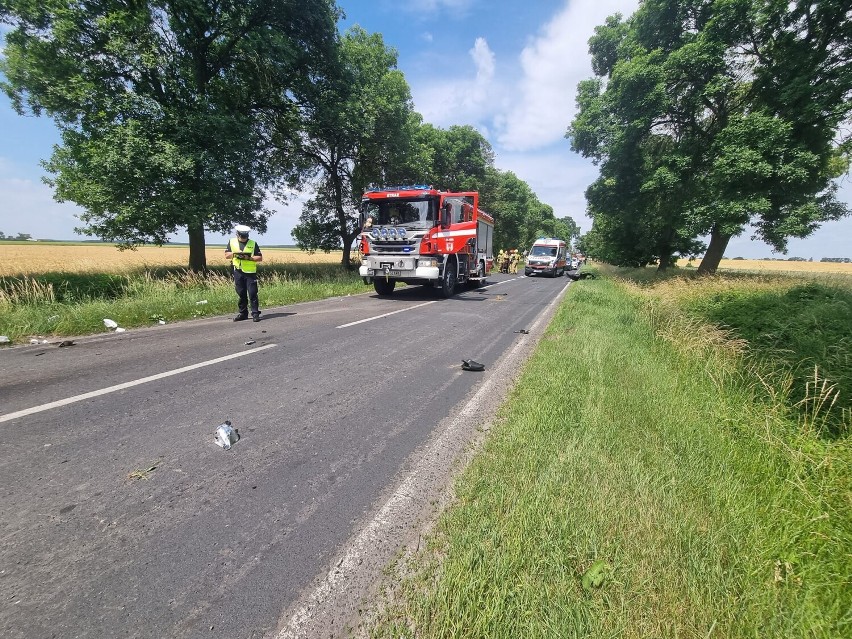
[0, 242, 341, 277]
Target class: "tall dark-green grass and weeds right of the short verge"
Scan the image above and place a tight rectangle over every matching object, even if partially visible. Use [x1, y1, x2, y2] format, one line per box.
[629, 273, 852, 437]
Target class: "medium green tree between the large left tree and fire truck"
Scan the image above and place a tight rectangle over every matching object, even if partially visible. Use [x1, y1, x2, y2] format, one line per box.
[290, 27, 418, 267]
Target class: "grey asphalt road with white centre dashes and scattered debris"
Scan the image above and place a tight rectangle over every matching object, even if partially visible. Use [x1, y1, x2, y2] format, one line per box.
[0, 275, 569, 639]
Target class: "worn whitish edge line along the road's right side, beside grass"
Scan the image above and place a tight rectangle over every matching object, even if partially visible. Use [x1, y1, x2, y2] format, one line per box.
[274, 282, 571, 639]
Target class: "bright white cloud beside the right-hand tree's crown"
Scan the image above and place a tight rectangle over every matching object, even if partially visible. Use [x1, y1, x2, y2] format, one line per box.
[496, 0, 638, 150]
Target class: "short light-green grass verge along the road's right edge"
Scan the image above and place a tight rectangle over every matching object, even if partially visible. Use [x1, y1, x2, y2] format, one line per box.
[360, 268, 852, 639]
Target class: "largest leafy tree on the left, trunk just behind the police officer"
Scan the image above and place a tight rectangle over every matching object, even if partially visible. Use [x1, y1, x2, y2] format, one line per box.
[0, 0, 337, 270]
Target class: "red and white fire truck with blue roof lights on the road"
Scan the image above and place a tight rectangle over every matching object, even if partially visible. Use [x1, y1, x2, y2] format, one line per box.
[359, 185, 494, 297]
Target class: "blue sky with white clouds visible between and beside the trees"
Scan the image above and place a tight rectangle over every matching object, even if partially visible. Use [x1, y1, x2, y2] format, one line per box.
[0, 0, 852, 260]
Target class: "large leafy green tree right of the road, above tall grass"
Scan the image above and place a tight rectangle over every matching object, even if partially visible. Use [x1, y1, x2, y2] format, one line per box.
[568, 0, 852, 273]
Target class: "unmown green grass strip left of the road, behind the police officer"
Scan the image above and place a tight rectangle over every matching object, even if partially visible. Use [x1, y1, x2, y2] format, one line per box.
[0, 264, 362, 344]
